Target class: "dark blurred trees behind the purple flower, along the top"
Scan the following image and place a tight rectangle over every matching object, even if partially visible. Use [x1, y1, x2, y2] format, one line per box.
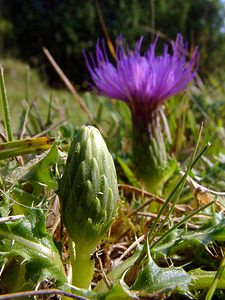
[0, 0, 225, 86]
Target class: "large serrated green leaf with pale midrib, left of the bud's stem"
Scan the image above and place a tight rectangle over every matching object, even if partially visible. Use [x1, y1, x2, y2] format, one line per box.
[0, 209, 66, 288]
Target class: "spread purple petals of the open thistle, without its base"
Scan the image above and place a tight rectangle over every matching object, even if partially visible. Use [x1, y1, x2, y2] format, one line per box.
[84, 34, 199, 110]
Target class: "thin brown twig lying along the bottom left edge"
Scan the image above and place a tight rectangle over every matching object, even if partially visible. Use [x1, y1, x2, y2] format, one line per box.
[0, 289, 88, 300]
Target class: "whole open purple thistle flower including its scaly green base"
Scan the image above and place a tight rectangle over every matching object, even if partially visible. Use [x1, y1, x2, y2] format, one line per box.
[84, 34, 199, 194]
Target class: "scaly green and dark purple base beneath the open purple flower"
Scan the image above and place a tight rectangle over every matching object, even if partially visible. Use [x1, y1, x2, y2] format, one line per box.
[132, 108, 176, 195]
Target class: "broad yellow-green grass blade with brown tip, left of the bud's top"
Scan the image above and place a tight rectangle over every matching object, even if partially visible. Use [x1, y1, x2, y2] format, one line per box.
[0, 137, 54, 160]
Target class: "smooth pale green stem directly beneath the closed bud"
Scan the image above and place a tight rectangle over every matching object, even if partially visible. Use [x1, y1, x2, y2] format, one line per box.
[69, 239, 94, 289]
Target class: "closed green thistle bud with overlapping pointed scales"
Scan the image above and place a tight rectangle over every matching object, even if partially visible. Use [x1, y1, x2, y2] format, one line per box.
[58, 126, 118, 253]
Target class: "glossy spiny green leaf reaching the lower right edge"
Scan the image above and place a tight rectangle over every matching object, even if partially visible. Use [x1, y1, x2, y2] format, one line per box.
[154, 209, 225, 270]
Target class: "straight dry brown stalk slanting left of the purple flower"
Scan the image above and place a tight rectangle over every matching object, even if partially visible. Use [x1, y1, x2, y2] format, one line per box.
[43, 48, 94, 121]
